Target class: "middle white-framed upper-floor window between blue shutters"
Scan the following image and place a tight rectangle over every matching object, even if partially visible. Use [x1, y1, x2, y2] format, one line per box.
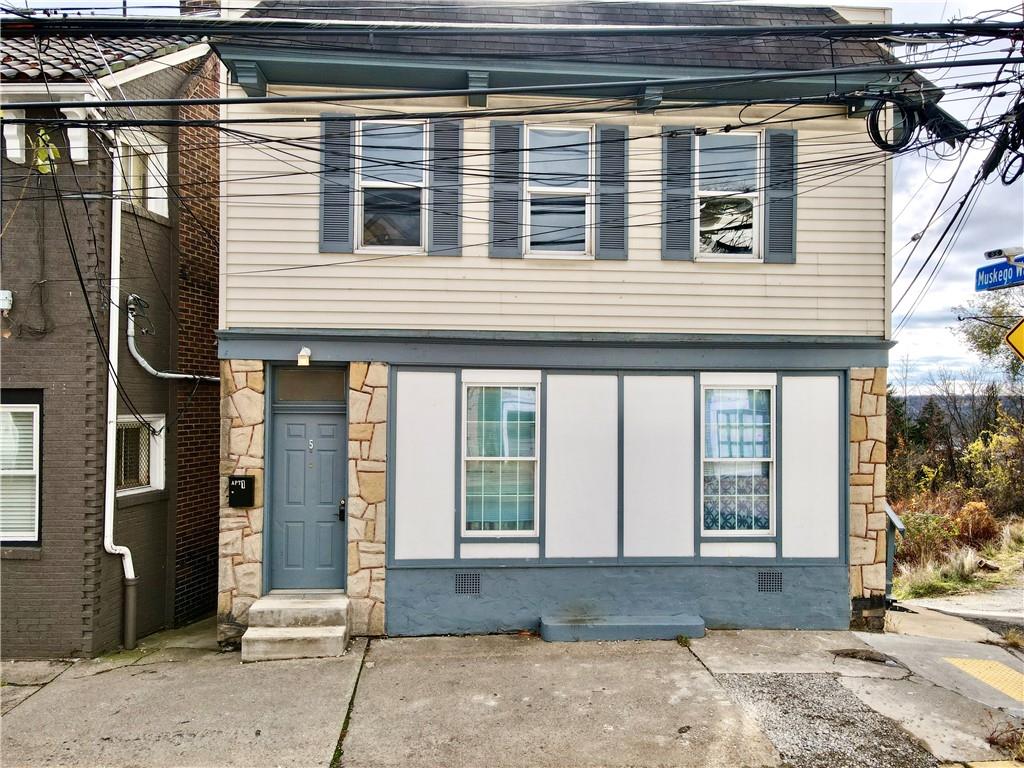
[525, 127, 593, 257]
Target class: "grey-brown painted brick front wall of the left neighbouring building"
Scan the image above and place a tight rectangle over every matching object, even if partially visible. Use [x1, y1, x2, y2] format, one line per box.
[0, 123, 110, 657]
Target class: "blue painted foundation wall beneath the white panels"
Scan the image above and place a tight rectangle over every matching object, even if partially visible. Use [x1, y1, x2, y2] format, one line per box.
[386, 564, 850, 639]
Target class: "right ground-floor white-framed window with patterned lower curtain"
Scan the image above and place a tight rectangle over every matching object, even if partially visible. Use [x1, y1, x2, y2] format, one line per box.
[701, 384, 775, 534]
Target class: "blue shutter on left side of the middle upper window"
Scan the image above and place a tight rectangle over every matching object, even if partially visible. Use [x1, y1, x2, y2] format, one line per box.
[489, 121, 523, 259]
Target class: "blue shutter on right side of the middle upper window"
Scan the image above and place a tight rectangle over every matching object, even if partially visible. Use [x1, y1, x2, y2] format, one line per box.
[595, 125, 629, 260]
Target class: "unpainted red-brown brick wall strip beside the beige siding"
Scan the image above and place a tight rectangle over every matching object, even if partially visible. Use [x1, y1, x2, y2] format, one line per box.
[172, 56, 220, 624]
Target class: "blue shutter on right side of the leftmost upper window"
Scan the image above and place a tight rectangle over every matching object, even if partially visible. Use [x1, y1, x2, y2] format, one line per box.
[427, 120, 462, 256]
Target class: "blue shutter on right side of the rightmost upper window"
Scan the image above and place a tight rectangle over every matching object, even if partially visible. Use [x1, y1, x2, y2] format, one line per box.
[764, 130, 797, 264]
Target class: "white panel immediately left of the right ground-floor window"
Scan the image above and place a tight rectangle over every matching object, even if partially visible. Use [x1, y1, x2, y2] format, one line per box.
[623, 376, 693, 557]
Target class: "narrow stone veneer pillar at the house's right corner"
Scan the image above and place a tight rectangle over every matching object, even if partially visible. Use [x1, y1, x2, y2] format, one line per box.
[850, 368, 887, 624]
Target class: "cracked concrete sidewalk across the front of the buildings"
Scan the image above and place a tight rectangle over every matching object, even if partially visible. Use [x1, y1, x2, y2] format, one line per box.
[0, 614, 1024, 768]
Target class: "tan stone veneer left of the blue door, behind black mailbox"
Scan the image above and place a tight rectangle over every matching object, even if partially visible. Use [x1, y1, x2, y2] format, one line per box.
[217, 360, 266, 643]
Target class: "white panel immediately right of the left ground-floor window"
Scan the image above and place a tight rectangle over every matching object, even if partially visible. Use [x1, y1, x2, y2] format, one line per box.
[544, 375, 618, 557]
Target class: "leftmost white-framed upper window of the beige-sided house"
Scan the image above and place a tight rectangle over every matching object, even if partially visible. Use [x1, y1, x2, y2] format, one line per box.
[355, 121, 427, 250]
